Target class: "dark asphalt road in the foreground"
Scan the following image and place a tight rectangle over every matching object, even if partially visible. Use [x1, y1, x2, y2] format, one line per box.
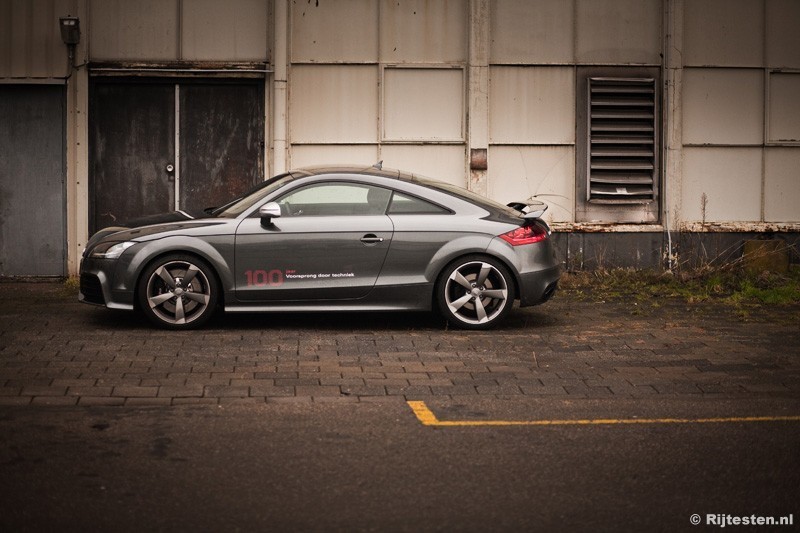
[0, 398, 800, 532]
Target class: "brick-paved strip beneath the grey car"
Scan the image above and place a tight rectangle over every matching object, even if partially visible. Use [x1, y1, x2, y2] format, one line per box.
[0, 282, 800, 406]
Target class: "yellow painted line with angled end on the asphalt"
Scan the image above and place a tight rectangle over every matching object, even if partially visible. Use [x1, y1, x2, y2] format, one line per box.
[406, 402, 800, 427]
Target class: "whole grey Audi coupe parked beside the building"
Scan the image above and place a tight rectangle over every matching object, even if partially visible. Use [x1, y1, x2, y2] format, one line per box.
[79, 167, 561, 329]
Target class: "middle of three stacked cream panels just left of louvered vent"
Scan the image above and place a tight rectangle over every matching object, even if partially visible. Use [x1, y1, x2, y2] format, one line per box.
[489, 67, 575, 144]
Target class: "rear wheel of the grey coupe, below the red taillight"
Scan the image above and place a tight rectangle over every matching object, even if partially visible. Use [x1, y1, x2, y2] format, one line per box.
[436, 255, 515, 329]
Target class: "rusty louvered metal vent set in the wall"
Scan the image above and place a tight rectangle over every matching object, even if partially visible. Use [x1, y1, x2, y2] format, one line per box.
[588, 78, 657, 204]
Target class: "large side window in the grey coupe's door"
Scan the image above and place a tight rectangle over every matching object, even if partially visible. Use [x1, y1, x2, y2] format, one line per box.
[278, 182, 392, 217]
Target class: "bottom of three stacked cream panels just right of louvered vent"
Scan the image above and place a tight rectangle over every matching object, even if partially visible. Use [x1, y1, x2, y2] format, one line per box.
[680, 148, 762, 222]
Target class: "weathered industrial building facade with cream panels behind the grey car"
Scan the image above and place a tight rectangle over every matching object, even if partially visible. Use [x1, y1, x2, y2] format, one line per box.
[0, 0, 800, 277]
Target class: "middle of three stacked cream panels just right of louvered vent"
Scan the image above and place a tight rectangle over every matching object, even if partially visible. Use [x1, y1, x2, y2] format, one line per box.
[683, 69, 764, 148]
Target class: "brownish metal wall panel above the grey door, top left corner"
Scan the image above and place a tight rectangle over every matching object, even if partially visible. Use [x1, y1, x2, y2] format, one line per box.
[0, 0, 78, 78]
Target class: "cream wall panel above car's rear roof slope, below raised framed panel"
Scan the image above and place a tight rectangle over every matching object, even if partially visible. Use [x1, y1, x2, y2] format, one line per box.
[381, 144, 467, 187]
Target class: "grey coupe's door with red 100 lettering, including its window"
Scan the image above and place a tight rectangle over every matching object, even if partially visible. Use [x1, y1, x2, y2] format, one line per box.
[235, 181, 393, 302]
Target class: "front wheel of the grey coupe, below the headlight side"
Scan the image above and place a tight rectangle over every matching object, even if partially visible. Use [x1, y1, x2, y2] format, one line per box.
[137, 254, 220, 329]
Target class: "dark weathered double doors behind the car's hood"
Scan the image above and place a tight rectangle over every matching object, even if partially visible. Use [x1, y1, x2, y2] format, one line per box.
[89, 79, 264, 232]
